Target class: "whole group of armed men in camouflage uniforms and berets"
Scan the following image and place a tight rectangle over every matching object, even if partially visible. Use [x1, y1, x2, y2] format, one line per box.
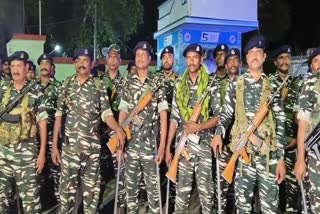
[0, 36, 320, 214]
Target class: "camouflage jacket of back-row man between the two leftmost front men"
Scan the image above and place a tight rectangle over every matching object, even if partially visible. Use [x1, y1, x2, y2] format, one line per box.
[38, 78, 61, 132]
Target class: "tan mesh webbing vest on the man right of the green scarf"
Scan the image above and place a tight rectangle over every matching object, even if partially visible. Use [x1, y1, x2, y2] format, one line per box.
[230, 75, 278, 155]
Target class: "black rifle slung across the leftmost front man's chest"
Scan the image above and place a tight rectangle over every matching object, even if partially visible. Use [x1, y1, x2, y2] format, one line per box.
[0, 82, 36, 123]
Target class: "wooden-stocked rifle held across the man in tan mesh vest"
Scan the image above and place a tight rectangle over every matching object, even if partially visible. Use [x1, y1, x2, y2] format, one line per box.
[222, 76, 289, 184]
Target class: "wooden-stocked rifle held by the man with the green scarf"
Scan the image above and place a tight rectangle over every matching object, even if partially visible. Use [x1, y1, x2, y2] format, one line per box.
[166, 76, 216, 183]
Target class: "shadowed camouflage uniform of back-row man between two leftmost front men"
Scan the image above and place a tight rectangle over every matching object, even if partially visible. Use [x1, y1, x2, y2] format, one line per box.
[37, 78, 61, 202]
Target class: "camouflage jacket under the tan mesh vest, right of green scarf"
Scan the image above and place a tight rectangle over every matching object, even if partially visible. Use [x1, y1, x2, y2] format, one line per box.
[216, 72, 286, 159]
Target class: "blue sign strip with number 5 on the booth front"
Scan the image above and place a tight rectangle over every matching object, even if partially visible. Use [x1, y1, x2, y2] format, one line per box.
[182, 29, 241, 46]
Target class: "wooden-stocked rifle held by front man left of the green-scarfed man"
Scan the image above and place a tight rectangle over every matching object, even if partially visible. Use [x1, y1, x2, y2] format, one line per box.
[107, 72, 173, 154]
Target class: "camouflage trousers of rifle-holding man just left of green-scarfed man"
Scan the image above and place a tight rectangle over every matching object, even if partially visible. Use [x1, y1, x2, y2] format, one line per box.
[125, 149, 160, 214]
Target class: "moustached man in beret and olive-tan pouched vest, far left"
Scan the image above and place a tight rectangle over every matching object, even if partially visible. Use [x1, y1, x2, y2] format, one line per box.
[0, 51, 48, 213]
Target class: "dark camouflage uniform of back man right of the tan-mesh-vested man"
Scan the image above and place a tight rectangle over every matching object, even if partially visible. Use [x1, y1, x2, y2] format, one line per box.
[269, 72, 300, 213]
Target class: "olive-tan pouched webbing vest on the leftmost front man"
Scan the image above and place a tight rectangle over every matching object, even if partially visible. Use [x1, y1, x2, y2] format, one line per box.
[0, 87, 37, 145]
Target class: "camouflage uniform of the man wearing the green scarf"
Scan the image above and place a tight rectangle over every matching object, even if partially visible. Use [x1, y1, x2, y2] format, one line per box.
[170, 72, 220, 214]
